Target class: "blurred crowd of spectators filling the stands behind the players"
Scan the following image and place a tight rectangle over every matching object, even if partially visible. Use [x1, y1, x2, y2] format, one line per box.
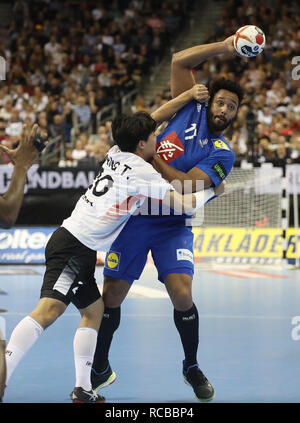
[0, 0, 300, 166]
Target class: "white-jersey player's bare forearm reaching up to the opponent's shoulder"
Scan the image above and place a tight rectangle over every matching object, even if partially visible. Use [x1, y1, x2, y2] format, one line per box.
[151, 84, 209, 123]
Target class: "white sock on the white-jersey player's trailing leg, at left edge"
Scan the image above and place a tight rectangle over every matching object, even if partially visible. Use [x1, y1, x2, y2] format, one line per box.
[6, 316, 44, 384]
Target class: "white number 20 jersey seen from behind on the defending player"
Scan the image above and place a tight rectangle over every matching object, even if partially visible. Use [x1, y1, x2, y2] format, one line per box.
[62, 146, 174, 251]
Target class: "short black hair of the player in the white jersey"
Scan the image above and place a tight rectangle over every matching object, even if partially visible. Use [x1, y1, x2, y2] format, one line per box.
[111, 112, 157, 153]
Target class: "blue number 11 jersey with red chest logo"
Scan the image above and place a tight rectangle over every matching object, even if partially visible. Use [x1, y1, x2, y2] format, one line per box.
[156, 100, 235, 186]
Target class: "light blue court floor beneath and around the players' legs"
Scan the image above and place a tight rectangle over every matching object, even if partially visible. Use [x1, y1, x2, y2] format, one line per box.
[0, 264, 300, 403]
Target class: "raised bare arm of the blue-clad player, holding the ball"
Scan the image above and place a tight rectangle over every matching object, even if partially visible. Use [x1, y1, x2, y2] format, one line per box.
[171, 35, 236, 97]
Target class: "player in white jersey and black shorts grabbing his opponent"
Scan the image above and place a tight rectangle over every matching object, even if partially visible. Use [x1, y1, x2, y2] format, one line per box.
[2, 85, 223, 403]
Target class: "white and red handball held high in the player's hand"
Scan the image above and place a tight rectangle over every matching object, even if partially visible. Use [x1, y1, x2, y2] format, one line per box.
[233, 25, 266, 57]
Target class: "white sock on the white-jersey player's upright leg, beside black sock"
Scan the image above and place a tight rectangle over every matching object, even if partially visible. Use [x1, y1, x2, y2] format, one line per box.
[73, 327, 98, 391]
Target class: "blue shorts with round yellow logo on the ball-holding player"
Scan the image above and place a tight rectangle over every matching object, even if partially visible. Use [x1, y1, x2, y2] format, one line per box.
[104, 215, 194, 284]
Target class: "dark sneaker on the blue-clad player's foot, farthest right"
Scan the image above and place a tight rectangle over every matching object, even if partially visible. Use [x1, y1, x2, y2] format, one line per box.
[182, 361, 215, 402]
